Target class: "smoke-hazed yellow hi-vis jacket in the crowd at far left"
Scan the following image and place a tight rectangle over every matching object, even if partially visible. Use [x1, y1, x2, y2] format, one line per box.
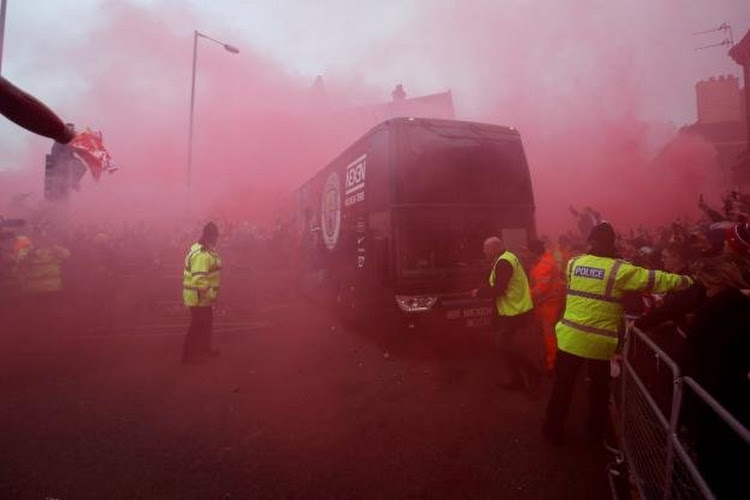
[18, 245, 70, 293]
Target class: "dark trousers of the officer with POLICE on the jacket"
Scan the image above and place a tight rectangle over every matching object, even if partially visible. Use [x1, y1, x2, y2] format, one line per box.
[544, 351, 610, 439]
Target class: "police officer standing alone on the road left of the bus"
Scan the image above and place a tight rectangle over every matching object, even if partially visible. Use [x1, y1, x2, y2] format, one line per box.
[182, 222, 221, 364]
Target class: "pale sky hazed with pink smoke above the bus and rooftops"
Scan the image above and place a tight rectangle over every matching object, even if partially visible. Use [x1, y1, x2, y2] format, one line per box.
[0, 0, 750, 227]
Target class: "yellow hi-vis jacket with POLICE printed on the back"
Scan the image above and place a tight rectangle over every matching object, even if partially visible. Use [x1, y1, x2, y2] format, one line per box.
[555, 255, 692, 360]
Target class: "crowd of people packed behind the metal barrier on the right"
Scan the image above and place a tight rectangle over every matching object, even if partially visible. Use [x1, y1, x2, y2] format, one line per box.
[560, 191, 750, 496]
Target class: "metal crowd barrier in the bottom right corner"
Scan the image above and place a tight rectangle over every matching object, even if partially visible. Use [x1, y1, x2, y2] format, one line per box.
[617, 328, 750, 500]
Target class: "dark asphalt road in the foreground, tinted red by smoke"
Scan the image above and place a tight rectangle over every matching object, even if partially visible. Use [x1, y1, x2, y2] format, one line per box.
[0, 301, 609, 500]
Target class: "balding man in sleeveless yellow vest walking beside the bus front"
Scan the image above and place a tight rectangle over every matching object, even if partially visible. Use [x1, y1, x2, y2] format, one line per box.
[475, 236, 541, 393]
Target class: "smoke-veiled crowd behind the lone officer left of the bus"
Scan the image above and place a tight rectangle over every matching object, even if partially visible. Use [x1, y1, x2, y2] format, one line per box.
[0, 214, 296, 335]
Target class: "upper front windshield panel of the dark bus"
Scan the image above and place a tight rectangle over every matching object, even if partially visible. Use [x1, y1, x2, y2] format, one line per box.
[394, 123, 533, 206]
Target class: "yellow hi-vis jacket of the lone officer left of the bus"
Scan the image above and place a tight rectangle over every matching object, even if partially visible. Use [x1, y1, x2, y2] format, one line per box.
[182, 243, 221, 307]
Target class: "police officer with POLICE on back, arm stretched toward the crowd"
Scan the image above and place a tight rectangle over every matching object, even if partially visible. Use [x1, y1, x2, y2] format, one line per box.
[543, 222, 692, 444]
